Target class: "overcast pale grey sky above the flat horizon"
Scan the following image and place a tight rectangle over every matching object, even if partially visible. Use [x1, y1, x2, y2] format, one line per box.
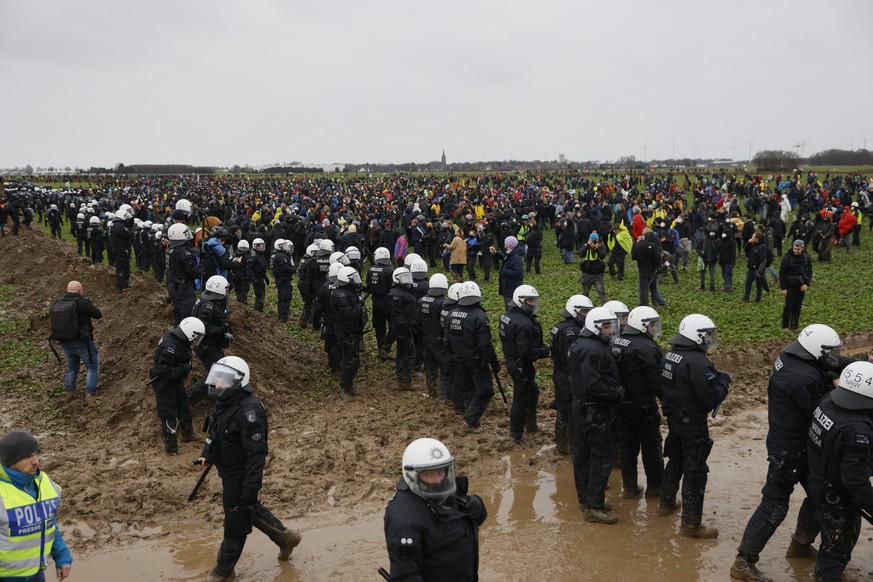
[0, 0, 873, 168]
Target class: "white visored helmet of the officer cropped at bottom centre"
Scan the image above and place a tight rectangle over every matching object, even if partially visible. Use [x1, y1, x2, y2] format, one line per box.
[402, 438, 456, 501]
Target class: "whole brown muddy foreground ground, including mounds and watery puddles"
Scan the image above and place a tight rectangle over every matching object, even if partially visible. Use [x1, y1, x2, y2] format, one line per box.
[0, 229, 873, 581]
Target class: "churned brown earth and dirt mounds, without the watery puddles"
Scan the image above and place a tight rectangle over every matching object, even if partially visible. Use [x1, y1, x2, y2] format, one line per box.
[0, 229, 873, 549]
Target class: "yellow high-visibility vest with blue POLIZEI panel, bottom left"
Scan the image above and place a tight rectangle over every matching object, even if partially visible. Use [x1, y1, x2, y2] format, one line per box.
[0, 471, 61, 577]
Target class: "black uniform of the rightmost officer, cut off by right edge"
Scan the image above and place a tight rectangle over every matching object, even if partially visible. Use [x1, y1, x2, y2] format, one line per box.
[807, 388, 873, 582]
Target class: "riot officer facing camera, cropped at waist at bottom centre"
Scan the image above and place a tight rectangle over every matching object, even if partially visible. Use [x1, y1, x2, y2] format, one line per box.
[385, 438, 488, 582]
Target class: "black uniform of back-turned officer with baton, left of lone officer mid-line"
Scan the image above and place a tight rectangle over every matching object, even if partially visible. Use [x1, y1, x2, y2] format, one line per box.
[443, 303, 500, 427]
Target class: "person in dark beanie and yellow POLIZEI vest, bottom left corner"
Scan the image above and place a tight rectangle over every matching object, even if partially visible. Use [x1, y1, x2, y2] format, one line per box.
[0, 430, 73, 582]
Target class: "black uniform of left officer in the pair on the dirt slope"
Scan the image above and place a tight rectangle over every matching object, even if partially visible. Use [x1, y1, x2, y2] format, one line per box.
[149, 327, 194, 454]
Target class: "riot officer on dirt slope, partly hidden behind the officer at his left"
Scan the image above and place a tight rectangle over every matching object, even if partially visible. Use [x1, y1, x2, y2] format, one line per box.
[188, 275, 233, 402]
